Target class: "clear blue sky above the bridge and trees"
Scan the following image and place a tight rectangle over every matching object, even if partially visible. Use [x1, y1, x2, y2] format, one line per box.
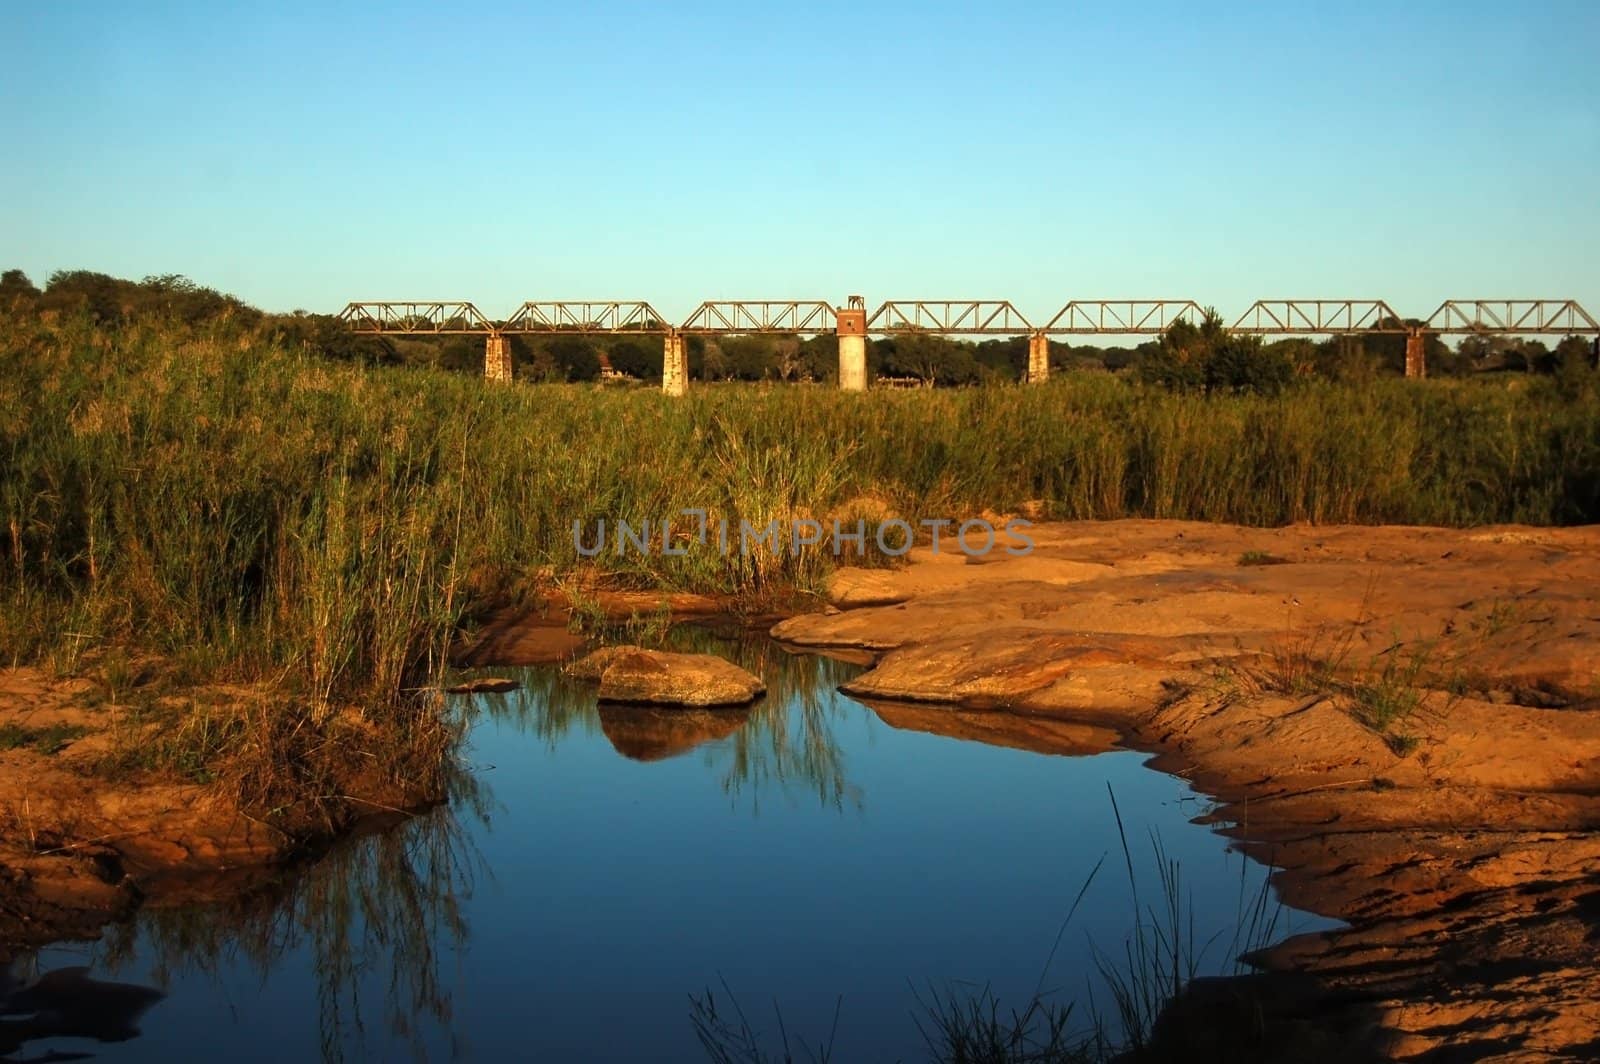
[0, 0, 1600, 318]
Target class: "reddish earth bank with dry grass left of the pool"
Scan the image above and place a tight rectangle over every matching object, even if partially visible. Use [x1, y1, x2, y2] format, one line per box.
[0, 661, 459, 962]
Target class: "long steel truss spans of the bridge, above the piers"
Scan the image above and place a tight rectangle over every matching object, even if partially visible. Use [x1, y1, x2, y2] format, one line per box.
[339, 299, 1600, 336]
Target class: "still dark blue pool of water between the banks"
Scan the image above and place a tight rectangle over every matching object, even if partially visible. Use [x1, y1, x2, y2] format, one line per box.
[12, 637, 1326, 1062]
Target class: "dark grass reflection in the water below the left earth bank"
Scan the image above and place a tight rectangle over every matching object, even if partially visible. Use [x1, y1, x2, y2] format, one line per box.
[86, 755, 486, 1061]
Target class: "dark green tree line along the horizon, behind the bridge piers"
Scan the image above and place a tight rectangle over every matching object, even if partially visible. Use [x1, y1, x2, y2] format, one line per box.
[0, 269, 1595, 394]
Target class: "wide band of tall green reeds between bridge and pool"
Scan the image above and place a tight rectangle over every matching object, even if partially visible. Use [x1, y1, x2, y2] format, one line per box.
[0, 307, 1600, 714]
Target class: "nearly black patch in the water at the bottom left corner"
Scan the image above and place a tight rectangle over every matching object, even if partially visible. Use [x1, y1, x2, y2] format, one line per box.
[0, 968, 166, 1061]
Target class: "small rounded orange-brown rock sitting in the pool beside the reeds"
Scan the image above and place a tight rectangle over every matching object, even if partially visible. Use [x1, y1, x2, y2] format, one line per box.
[570, 646, 766, 706]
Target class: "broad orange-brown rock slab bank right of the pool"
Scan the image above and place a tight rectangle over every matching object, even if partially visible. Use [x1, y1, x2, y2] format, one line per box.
[773, 522, 1600, 1059]
